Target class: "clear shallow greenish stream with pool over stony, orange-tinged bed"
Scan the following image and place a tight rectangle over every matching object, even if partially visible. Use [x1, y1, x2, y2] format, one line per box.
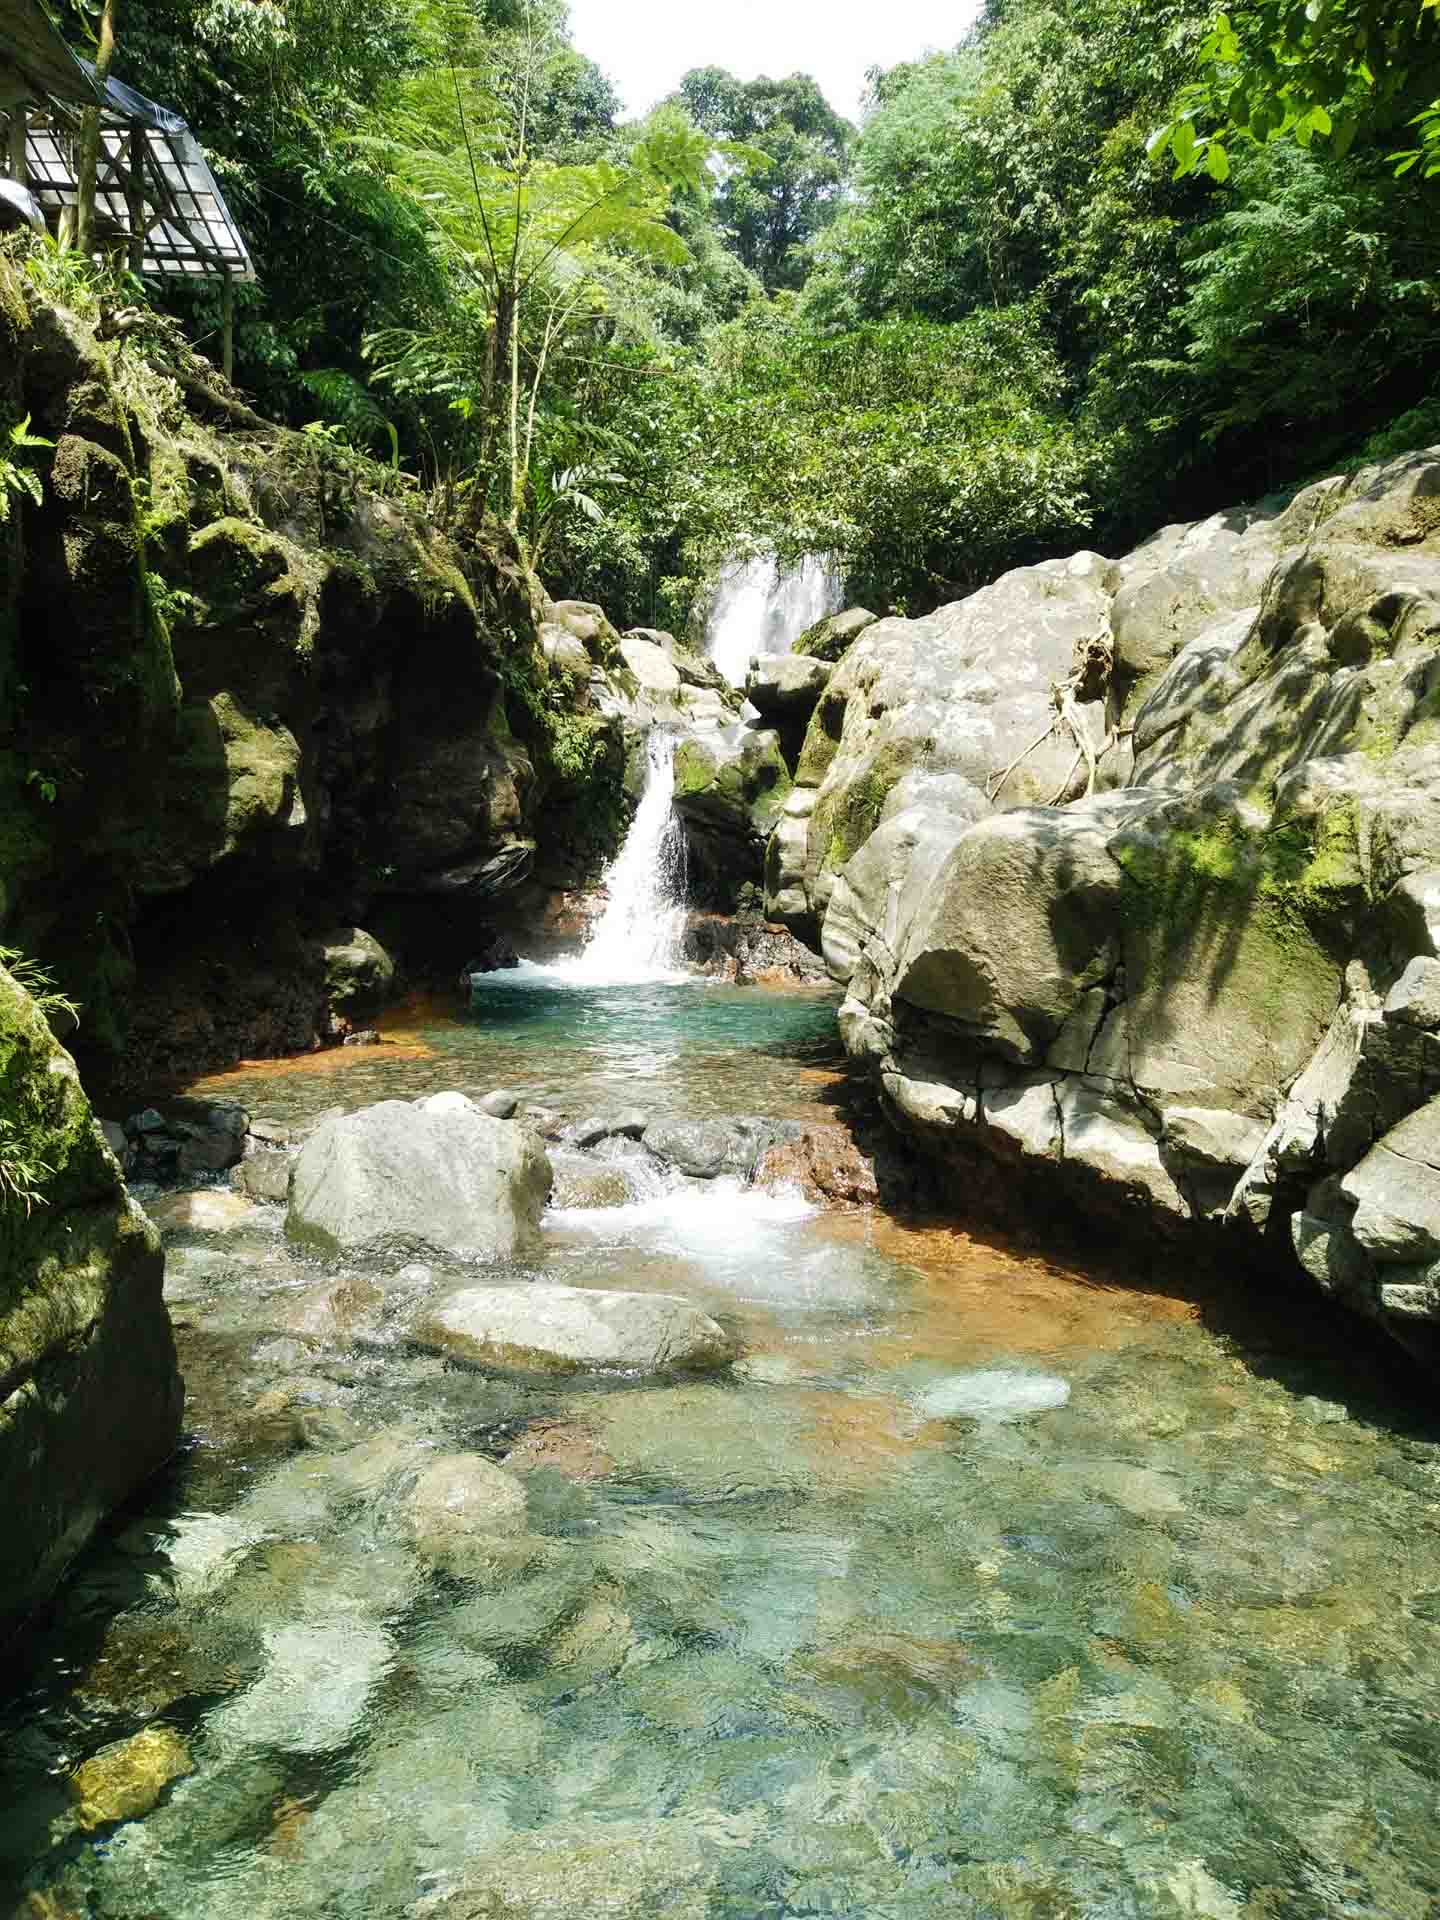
[0, 977, 1440, 1920]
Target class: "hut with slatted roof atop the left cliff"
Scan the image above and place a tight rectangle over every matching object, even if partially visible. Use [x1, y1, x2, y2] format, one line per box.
[0, 0, 255, 378]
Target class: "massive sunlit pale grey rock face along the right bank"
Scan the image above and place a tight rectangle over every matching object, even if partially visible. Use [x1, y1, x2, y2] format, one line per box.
[814, 455, 1440, 1361]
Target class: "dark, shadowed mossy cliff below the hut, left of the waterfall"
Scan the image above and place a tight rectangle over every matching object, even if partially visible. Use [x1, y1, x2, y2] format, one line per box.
[0, 257, 626, 1083]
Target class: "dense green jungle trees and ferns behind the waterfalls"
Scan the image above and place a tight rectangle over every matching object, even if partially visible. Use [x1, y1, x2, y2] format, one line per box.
[81, 0, 1440, 626]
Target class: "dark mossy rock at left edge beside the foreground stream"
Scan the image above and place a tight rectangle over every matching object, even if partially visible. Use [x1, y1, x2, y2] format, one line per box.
[0, 968, 182, 1640]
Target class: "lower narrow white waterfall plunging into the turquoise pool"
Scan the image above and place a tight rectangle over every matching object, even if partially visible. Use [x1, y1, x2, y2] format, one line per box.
[568, 730, 685, 983]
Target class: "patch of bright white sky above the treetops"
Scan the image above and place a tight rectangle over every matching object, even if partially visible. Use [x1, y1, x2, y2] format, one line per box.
[570, 0, 979, 119]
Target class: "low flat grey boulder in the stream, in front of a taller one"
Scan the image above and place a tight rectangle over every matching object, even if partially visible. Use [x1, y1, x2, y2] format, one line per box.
[415, 1284, 737, 1373]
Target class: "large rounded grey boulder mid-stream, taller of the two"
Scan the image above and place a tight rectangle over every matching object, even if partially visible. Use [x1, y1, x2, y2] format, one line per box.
[286, 1092, 551, 1260]
